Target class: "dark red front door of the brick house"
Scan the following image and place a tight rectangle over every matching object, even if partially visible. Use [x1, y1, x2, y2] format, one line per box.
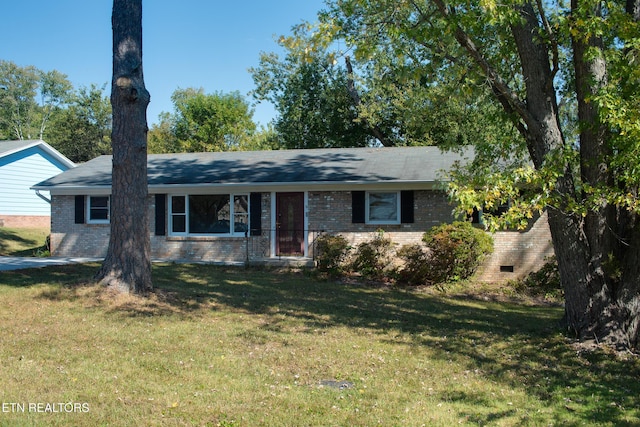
[276, 193, 305, 256]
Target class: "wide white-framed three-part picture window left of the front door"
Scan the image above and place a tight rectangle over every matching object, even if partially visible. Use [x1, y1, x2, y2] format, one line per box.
[169, 194, 249, 236]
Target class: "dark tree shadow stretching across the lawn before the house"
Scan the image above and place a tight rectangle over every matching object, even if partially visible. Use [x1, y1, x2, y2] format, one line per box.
[0, 264, 640, 425]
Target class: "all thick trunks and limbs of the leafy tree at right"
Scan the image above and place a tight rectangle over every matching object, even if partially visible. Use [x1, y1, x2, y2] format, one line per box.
[432, 0, 640, 348]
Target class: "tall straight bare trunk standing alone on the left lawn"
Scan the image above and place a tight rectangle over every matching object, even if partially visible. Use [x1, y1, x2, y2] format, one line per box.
[97, 0, 152, 293]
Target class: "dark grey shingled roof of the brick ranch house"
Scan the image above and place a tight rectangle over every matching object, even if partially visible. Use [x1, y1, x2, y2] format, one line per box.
[34, 147, 473, 190]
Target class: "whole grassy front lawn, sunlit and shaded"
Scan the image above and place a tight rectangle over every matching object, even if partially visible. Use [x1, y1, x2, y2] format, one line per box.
[0, 264, 640, 426]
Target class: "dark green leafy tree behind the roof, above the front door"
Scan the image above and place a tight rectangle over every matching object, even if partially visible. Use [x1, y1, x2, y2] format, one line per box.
[250, 42, 372, 149]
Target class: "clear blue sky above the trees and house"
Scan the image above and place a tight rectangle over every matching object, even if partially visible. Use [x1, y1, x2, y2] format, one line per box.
[0, 0, 324, 125]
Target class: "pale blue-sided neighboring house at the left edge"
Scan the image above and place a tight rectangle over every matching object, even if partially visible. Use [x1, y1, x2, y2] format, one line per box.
[0, 141, 75, 227]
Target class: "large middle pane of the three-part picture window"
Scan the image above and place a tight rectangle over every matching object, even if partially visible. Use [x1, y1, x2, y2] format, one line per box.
[189, 194, 231, 234]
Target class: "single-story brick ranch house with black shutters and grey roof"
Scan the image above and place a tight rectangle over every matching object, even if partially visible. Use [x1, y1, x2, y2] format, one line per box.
[33, 147, 552, 280]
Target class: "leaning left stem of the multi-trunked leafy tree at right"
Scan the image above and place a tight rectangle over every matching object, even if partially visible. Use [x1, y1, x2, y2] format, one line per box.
[511, 3, 606, 334]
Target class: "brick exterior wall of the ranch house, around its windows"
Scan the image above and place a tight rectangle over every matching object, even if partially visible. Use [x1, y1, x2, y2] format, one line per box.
[51, 191, 553, 281]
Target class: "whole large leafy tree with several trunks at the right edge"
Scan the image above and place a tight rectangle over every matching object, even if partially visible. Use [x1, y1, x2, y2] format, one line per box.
[318, 0, 640, 348]
